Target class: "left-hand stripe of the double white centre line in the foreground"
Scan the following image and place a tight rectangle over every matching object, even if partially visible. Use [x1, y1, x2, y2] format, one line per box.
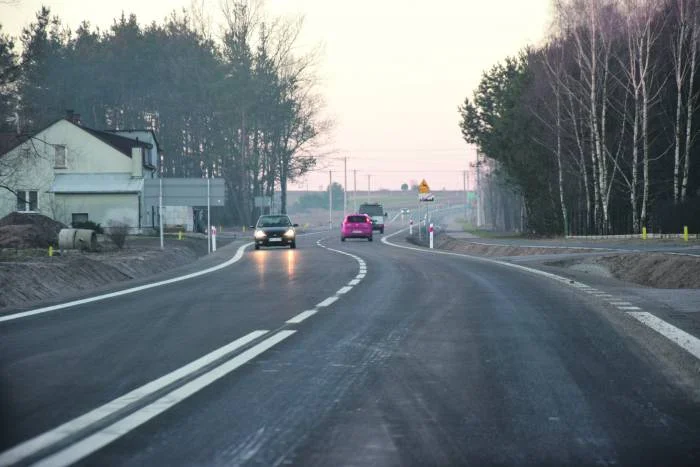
[0, 330, 269, 466]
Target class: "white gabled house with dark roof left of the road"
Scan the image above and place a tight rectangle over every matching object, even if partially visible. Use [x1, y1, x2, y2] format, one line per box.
[0, 115, 159, 230]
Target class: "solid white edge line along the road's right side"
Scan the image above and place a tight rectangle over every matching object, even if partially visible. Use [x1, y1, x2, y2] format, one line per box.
[382, 229, 700, 359]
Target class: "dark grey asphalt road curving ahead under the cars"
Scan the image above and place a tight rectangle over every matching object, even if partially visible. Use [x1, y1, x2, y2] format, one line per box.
[0, 227, 700, 466]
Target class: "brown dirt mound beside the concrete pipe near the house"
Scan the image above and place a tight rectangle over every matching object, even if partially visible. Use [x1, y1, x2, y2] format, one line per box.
[0, 212, 66, 248]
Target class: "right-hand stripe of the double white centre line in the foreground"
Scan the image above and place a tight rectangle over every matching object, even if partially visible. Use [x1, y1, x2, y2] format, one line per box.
[34, 330, 296, 467]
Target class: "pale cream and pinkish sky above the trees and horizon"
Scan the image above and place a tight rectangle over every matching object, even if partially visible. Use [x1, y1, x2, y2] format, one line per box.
[0, 0, 551, 190]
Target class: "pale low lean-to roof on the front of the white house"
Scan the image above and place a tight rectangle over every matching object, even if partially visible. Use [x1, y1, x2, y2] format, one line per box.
[49, 173, 143, 194]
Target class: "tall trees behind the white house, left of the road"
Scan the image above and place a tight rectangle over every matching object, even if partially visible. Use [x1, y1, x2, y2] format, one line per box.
[0, 0, 329, 225]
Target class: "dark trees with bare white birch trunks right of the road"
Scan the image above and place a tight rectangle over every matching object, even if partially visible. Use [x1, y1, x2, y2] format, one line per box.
[459, 0, 700, 235]
